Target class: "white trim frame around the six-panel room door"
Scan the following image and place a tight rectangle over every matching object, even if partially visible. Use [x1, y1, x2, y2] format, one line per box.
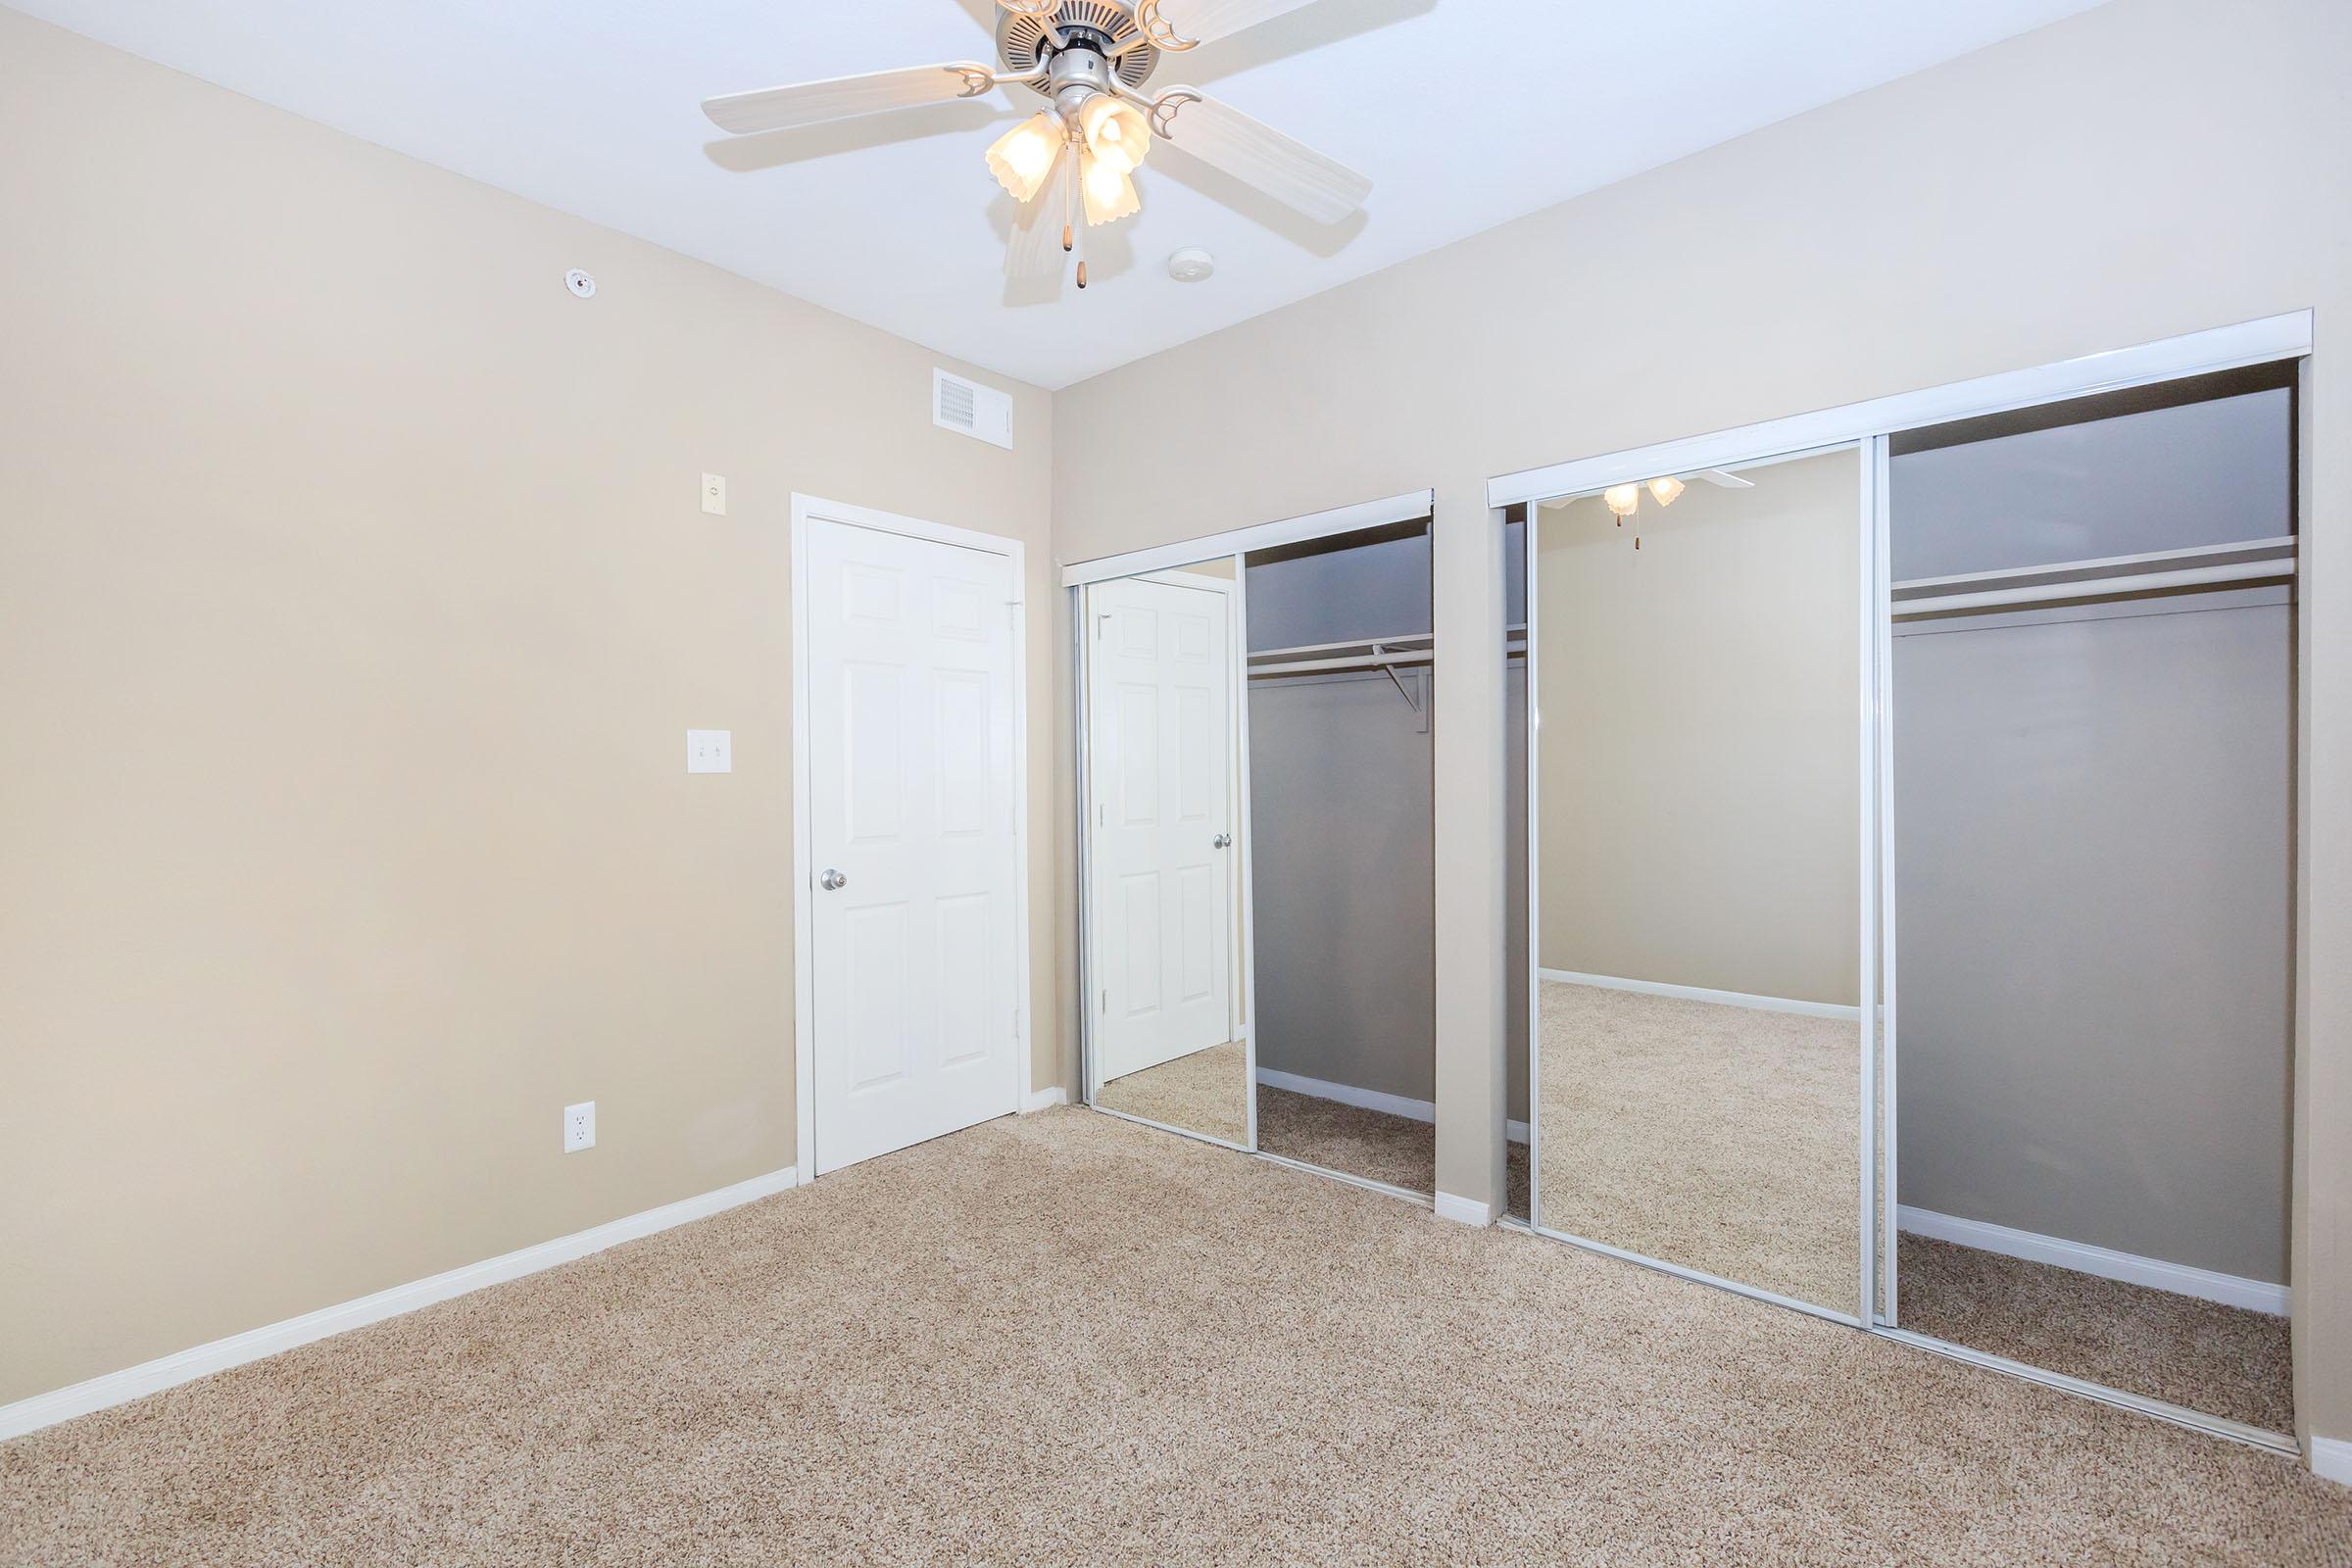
[790, 491, 1030, 1180]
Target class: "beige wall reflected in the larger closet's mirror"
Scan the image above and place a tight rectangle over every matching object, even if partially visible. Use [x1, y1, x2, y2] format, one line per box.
[1536, 461, 1863, 1006]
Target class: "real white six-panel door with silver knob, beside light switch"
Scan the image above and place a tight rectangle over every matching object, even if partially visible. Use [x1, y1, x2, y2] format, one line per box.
[802, 517, 1021, 1173]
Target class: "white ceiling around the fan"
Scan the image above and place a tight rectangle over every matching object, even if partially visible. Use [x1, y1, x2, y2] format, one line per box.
[10, 0, 2095, 388]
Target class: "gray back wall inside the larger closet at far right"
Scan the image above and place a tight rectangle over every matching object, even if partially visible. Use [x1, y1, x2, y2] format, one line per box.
[1893, 390, 2293, 1281]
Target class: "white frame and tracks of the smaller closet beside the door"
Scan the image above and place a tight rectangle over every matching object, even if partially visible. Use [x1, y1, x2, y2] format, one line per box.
[1060, 489, 1437, 1189]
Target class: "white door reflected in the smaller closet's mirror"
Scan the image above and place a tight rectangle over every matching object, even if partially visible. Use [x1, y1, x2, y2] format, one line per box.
[1087, 571, 1237, 1084]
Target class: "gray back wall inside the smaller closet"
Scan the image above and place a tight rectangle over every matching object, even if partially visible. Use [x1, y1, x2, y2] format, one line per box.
[1247, 534, 1437, 1101]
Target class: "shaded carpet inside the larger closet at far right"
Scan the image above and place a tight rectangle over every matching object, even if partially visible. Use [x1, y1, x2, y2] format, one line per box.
[1895, 1232, 2295, 1432]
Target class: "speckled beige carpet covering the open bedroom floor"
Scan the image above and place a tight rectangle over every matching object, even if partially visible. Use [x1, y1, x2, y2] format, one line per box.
[0, 1109, 2352, 1568]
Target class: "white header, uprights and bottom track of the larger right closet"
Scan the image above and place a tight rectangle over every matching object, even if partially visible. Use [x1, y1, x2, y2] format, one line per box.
[1487, 308, 2315, 1452]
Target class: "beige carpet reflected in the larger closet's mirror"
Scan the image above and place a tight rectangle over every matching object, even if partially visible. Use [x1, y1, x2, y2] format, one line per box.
[1541, 980, 1863, 1312]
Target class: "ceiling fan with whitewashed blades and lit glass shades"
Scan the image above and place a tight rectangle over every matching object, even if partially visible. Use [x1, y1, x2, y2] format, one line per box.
[704, 0, 1371, 289]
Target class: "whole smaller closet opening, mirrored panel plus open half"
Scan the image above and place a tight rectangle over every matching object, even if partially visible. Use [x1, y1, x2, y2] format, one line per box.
[1080, 517, 1437, 1197]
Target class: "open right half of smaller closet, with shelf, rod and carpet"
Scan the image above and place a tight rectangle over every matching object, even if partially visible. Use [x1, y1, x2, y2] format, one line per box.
[1247, 519, 1437, 1195]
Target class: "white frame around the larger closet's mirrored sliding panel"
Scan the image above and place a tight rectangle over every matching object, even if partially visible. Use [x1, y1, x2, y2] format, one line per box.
[1489, 441, 1886, 1328]
